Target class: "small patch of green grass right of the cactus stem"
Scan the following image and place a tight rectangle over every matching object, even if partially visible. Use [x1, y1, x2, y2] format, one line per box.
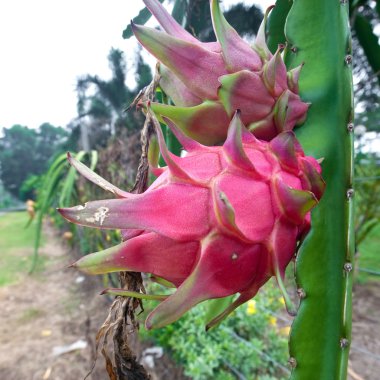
[357, 224, 380, 283]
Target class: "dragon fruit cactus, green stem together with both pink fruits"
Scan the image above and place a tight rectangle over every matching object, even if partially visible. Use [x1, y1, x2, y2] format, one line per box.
[61, 0, 353, 380]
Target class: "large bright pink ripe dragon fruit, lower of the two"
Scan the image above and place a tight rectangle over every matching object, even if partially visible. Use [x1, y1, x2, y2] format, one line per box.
[59, 109, 325, 328]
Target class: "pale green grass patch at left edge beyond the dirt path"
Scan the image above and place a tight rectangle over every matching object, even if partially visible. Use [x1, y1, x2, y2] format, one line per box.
[0, 212, 45, 286]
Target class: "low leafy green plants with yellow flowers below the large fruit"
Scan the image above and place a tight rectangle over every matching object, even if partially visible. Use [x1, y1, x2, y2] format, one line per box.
[140, 283, 290, 380]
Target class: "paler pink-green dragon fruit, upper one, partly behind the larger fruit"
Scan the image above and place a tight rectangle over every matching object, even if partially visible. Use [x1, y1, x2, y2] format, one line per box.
[132, 0, 308, 145]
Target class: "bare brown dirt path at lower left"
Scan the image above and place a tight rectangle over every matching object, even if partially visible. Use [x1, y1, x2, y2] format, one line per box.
[0, 224, 108, 380]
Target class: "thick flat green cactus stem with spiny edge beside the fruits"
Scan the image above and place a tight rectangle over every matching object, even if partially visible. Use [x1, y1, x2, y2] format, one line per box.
[285, 0, 353, 380]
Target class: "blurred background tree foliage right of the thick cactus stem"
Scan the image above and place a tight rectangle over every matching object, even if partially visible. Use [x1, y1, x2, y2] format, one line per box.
[350, 0, 380, 274]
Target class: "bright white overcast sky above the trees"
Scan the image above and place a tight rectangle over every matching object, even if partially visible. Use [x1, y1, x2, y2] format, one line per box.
[0, 0, 274, 132]
